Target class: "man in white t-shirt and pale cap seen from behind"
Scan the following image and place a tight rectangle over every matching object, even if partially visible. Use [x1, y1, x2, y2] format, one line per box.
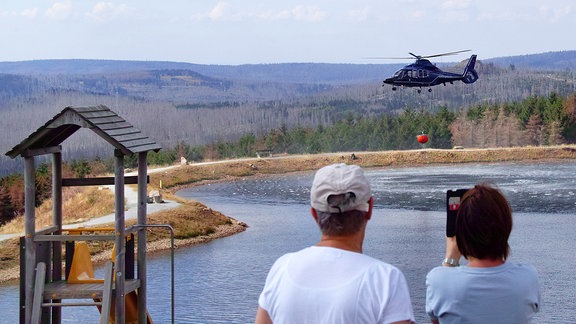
[256, 163, 414, 324]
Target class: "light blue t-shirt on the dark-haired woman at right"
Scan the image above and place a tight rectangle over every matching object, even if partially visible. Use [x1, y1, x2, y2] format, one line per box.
[426, 262, 540, 324]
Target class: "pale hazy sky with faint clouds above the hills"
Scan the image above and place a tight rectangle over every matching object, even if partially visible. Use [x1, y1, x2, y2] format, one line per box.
[0, 0, 576, 65]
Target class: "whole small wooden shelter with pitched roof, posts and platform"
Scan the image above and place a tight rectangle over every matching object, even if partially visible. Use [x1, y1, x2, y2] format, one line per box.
[6, 106, 160, 323]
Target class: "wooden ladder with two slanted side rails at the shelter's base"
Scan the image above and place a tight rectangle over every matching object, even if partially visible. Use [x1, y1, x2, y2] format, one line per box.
[32, 261, 114, 324]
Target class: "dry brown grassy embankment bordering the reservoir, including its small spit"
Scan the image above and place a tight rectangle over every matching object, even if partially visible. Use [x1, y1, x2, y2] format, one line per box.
[0, 146, 576, 281]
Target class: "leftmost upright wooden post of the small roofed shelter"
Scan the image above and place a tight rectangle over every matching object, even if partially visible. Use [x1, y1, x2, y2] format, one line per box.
[24, 156, 36, 323]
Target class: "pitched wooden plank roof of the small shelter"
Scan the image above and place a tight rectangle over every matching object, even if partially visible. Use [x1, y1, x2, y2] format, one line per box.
[6, 105, 161, 158]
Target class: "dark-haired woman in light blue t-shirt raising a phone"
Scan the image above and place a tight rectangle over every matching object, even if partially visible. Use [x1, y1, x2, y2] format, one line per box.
[426, 184, 540, 323]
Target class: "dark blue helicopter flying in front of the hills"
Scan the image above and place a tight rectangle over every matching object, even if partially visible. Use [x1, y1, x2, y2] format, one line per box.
[382, 50, 478, 93]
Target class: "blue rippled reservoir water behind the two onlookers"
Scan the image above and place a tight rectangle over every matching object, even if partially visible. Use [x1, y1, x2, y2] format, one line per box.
[0, 161, 576, 323]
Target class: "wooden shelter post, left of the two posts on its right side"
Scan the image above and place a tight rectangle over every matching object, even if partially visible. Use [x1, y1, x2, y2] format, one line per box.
[114, 149, 126, 323]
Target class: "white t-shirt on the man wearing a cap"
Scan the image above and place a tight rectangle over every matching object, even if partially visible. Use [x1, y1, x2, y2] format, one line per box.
[258, 246, 414, 324]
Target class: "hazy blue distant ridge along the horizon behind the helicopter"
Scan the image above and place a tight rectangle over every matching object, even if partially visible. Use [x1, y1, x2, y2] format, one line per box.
[0, 51, 576, 84]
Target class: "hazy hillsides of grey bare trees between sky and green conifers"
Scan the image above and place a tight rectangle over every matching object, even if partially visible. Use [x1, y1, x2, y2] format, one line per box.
[0, 51, 576, 176]
